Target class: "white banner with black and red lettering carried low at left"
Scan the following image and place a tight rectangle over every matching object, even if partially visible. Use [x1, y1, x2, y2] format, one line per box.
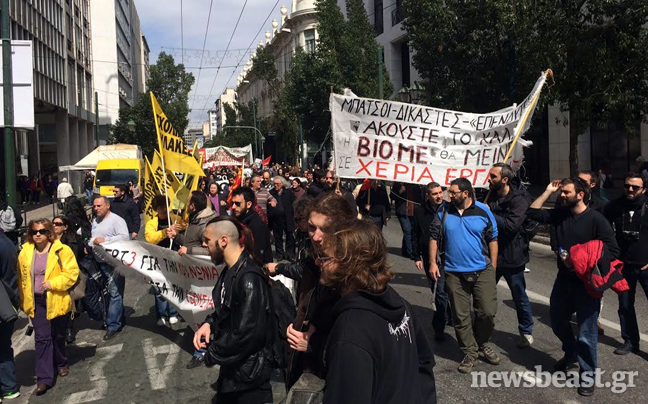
[95, 240, 223, 329]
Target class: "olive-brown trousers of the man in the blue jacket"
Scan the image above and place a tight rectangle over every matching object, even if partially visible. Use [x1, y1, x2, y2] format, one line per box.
[446, 265, 497, 359]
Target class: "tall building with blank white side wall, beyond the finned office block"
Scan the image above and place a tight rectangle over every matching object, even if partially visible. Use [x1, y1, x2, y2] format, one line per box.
[91, 0, 149, 143]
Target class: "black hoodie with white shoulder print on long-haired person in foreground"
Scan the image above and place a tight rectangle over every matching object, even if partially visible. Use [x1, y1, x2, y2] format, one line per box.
[324, 286, 436, 404]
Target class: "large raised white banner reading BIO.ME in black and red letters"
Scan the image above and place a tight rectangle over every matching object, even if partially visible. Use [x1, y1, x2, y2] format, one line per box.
[329, 73, 547, 188]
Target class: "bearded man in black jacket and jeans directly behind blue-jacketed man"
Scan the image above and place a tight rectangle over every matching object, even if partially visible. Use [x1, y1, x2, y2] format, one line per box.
[488, 163, 533, 348]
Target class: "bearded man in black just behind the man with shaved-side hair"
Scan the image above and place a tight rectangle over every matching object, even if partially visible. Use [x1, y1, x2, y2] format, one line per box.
[232, 187, 272, 264]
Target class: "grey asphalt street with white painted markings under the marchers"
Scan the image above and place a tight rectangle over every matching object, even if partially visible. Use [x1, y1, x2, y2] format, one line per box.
[6, 221, 648, 404]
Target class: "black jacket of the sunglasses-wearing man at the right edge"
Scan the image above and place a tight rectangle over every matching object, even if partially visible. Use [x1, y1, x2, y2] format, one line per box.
[605, 195, 648, 266]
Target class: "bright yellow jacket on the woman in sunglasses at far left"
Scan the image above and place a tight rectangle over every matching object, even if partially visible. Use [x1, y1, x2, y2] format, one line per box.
[18, 240, 79, 320]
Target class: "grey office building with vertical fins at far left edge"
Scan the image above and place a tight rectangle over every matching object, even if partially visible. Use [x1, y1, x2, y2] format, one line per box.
[0, 0, 96, 192]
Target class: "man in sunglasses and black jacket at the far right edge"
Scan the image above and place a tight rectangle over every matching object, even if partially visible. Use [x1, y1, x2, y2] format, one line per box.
[605, 173, 648, 355]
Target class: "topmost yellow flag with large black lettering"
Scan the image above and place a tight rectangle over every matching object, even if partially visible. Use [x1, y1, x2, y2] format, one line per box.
[151, 92, 205, 176]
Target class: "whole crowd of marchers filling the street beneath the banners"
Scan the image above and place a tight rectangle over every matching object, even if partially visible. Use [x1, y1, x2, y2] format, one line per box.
[0, 159, 648, 403]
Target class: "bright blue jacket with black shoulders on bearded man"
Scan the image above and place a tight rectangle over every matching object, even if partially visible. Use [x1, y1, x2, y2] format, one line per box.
[430, 201, 497, 272]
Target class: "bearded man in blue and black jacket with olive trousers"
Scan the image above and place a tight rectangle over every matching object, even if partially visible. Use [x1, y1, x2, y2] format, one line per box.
[429, 178, 500, 373]
